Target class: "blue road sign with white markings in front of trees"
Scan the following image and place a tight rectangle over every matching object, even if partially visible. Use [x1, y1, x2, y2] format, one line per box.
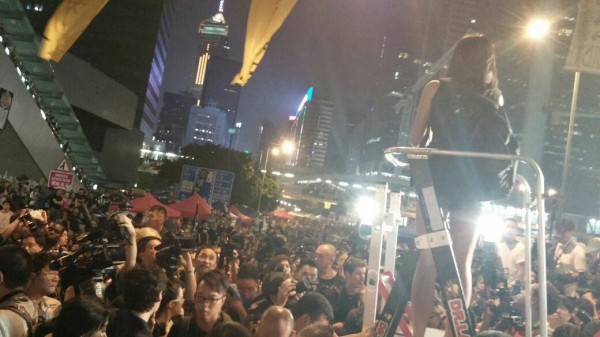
[179, 165, 235, 206]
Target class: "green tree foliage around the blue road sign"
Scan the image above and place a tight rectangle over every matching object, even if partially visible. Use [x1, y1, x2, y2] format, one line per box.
[159, 144, 282, 210]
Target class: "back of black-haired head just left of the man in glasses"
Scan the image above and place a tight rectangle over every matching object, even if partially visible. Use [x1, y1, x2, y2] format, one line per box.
[121, 265, 167, 312]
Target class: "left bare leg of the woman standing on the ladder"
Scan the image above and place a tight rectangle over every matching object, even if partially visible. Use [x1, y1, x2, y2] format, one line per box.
[411, 207, 437, 337]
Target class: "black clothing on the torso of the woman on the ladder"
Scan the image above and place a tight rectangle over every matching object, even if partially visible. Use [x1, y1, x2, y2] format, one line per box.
[428, 79, 519, 202]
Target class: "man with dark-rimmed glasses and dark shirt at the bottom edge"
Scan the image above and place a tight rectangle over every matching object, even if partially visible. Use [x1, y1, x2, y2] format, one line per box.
[168, 270, 232, 337]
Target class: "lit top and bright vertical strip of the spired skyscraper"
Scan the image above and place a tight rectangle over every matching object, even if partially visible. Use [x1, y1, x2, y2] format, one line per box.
[190, 0, 230, 102]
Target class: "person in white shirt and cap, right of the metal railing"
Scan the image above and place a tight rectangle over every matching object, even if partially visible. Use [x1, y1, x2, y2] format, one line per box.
[554, 219, 587, 297]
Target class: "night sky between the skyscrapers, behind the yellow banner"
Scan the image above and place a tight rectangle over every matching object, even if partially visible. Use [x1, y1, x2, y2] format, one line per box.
[162, 0, 401, 151]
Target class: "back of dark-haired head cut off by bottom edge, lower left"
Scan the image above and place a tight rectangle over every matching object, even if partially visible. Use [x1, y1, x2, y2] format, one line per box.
[53, 297, 108, 337]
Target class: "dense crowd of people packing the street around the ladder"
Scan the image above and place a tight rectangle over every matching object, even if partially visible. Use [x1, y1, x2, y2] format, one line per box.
[0, 173, 600, 337]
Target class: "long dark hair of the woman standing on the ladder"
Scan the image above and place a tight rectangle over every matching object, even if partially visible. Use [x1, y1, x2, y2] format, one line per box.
[446, 34, 498, 94]
